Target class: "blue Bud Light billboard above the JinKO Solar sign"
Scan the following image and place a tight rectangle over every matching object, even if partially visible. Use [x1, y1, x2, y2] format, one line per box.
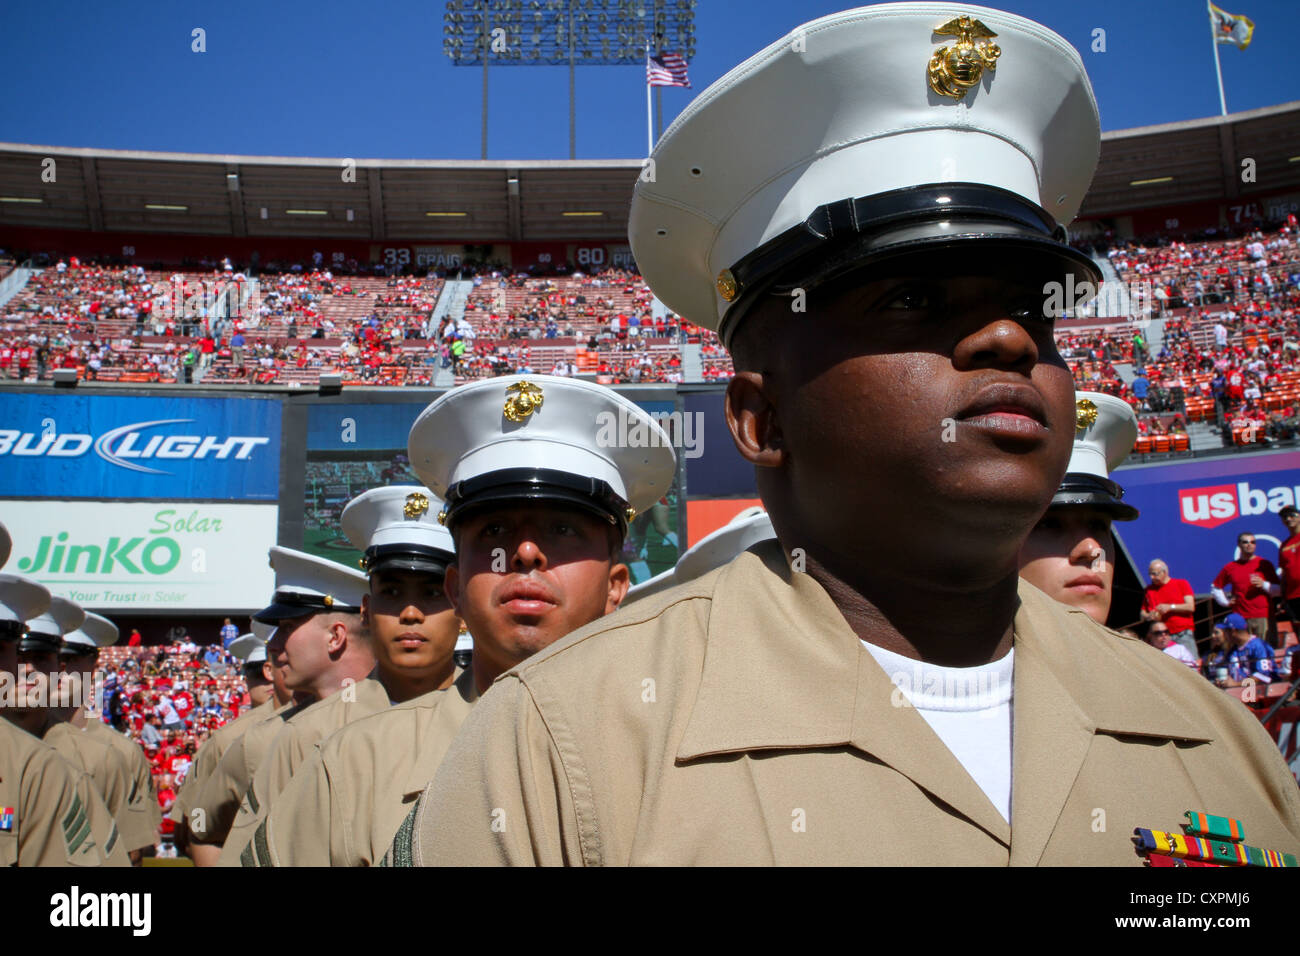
[0, 393, 280, 501]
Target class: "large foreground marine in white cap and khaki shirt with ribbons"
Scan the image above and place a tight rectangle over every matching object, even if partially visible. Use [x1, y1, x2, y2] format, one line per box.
[405, 3, 1300, 865]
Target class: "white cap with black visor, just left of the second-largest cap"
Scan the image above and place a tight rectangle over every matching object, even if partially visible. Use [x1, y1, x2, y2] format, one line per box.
[339, 485, 456, 576]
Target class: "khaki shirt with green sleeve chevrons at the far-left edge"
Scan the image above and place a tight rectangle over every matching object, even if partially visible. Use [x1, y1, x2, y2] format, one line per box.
[0, 719, 130, 866]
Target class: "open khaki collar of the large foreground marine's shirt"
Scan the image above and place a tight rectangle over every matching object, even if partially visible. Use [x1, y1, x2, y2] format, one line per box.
[676, 541, 1214, 849]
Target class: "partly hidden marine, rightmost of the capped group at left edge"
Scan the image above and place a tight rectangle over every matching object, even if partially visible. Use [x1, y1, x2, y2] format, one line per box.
[59, 611, 163, 864]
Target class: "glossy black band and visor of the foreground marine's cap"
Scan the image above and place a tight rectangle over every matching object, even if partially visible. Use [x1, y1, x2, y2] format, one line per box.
[719, 182, 1101, 346]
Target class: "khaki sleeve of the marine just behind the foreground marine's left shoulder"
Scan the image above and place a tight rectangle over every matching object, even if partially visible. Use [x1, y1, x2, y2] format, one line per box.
[241, 747, 335, 866]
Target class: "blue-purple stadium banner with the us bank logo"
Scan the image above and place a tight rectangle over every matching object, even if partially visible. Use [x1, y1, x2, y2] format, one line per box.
[1112, 451, 1300, 594]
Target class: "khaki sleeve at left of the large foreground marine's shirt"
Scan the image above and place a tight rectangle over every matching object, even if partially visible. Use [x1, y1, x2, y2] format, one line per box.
[416, 678, 585, 866]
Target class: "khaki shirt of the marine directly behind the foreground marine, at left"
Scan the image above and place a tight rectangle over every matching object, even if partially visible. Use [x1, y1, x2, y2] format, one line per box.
[244, 670, 478, 866]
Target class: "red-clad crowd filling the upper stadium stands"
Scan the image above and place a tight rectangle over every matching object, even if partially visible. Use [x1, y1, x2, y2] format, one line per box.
[0, 222, 1300, 447]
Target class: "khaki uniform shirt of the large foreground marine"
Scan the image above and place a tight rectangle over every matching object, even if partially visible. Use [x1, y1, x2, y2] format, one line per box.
[394, 541, 1300, 866]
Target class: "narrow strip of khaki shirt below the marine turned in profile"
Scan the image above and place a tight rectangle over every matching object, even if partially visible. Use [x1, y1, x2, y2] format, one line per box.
[218, 678, 391, 866]
